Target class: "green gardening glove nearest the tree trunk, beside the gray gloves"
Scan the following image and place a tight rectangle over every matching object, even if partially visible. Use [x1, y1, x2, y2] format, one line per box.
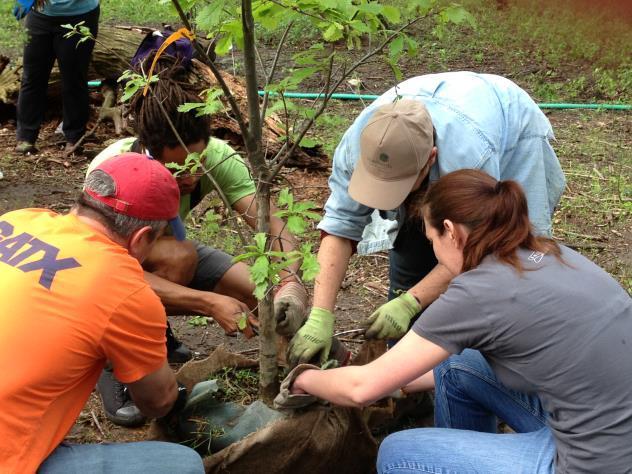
[287, 308, 336, 367]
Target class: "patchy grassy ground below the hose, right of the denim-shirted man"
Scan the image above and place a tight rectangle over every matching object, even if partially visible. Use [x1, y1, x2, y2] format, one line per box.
[553, 112, 632, 294]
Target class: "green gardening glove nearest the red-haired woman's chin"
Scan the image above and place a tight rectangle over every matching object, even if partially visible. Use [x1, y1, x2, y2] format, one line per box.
[364, 292, 421, 339]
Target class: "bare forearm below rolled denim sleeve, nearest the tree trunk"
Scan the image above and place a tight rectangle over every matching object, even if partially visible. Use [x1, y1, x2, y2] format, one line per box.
[314, 235, 351, 313]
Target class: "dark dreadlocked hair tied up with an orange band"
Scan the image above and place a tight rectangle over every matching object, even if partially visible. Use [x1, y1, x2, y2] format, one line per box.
[129, 54, 211, 159]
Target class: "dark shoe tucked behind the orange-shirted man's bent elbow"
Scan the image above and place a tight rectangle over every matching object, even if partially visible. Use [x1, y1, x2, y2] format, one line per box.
[97, 369, 146, 428]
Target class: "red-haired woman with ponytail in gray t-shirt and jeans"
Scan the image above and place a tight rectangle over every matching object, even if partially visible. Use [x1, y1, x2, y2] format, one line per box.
[279, 170, 632, 473]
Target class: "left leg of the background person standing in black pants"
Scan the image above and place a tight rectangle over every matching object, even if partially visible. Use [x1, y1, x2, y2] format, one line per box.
[16, 12, 55, 153]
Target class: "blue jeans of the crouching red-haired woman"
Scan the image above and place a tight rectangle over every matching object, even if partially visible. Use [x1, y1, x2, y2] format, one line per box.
[377, 349, 555, 474]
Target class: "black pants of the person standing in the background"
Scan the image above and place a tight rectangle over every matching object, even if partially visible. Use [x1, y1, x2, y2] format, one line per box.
[17, 7, 100, 143]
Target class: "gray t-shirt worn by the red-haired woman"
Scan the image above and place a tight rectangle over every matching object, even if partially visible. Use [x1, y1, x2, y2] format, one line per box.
[413, 247, 632, 473]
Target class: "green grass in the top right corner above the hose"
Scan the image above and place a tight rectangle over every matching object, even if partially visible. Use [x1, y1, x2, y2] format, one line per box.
[449, 0, 632, 103]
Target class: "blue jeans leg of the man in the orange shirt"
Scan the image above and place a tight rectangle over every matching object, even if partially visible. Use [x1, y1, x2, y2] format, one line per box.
[37, 441, 204, 474]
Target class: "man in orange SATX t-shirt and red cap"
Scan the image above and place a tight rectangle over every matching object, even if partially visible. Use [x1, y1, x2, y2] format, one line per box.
[0, 153, 203, 473]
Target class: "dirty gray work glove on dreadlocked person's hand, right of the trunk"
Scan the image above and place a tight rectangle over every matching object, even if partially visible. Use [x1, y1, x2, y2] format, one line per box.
[274, 281, 307, 339]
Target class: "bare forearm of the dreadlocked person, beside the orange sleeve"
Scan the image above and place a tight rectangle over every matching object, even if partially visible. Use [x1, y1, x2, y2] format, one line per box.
[145, 272, 212, 315]
